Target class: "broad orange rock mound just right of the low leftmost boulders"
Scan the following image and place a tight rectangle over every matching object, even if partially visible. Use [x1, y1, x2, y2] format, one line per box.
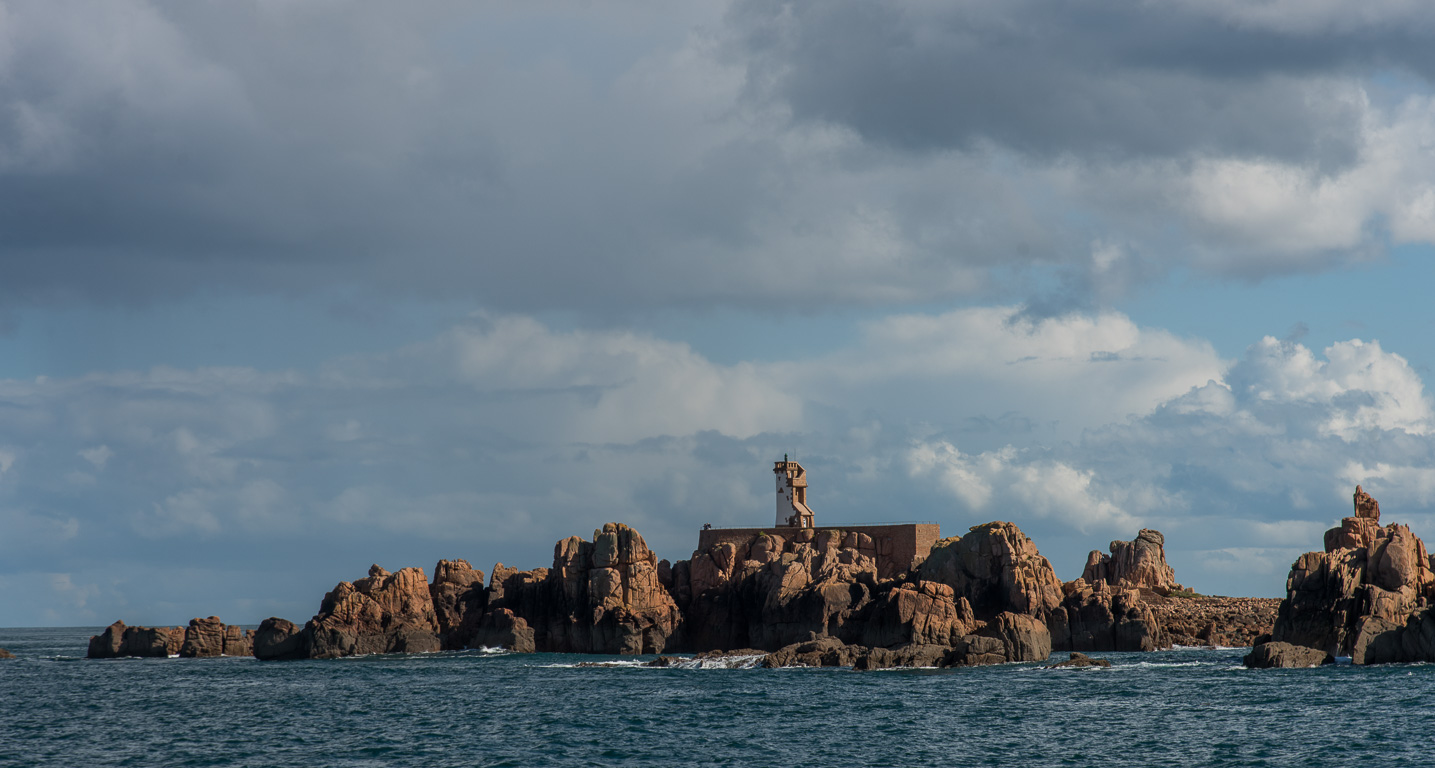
[304, 566, 441, 659]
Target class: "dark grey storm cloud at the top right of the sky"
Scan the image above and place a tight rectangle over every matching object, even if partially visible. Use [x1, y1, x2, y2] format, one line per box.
[732, 0, 1435, 164]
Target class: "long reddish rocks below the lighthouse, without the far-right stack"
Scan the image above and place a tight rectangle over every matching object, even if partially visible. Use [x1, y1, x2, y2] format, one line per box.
[89, 521, 1279, 669]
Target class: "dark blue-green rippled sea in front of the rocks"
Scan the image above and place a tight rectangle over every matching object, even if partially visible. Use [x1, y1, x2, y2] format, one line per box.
[0, 627, 1435, 768]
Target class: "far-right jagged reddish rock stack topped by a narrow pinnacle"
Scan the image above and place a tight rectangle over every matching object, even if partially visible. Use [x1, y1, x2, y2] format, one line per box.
[1271, 485, 1435, 665]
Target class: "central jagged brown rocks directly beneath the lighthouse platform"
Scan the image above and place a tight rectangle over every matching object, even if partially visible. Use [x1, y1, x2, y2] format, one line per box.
[670, 523, 1059, 668]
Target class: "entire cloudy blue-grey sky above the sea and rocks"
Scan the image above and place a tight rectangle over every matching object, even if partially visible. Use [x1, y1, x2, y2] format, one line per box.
[0, 0, 1435, 626]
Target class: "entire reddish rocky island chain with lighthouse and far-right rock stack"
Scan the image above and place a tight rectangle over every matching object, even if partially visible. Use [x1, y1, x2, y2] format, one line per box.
[89, 458, 1435, 669]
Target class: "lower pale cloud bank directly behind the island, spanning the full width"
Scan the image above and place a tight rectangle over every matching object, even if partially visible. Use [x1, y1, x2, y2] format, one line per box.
[0, 306, 1435, 622]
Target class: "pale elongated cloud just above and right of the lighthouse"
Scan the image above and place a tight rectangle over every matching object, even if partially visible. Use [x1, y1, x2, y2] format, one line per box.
[791, 307, 1225, 439]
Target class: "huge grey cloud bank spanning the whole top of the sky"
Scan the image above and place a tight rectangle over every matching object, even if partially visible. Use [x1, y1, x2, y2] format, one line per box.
[0, 0, 1435, 319]
